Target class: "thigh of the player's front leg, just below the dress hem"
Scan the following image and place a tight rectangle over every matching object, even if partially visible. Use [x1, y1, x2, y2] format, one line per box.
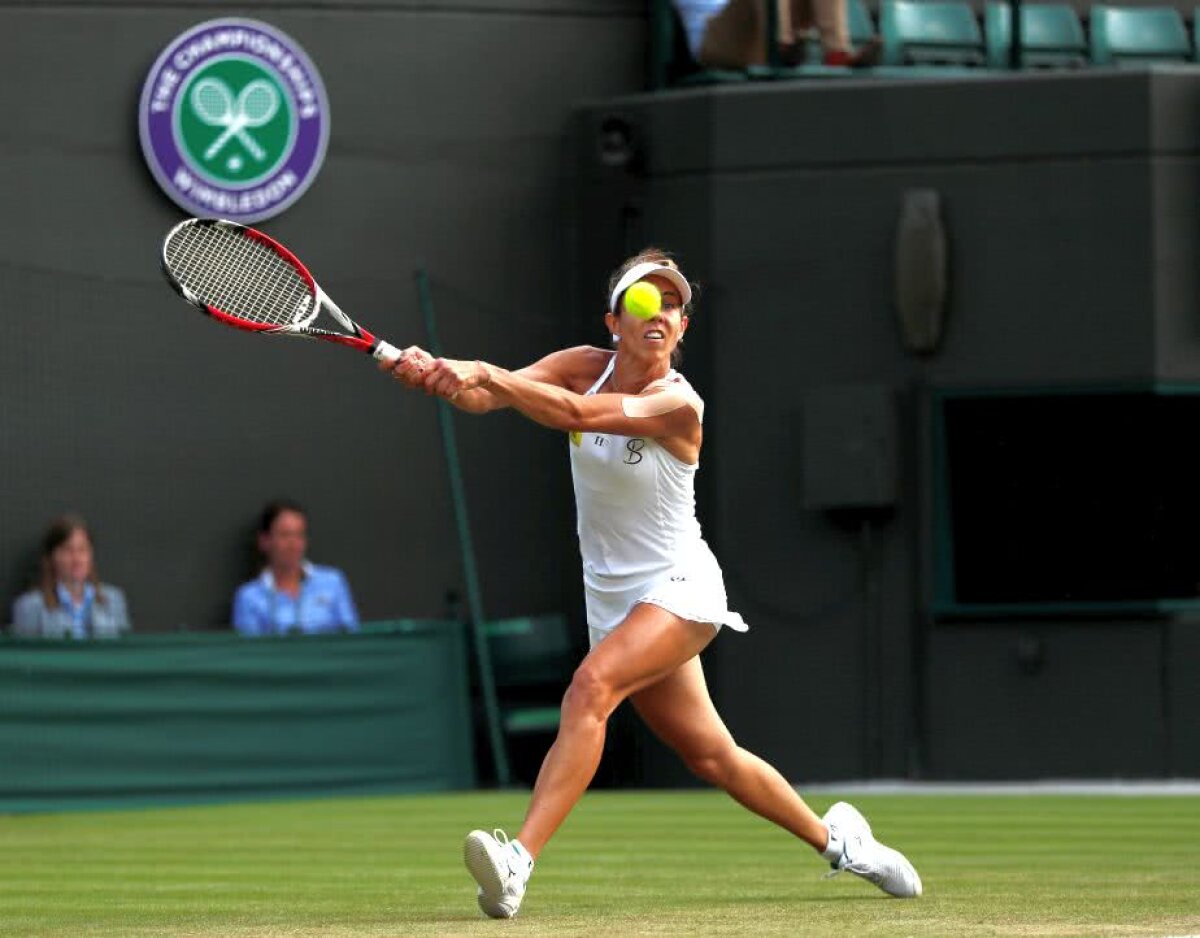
[576, 602, 715, 698]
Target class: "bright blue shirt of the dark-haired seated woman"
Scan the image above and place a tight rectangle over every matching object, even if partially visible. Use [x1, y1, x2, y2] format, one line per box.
[233, 563, 359, 636]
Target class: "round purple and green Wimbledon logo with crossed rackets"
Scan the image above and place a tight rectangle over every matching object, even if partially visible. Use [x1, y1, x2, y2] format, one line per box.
[138, 19, 329, 222]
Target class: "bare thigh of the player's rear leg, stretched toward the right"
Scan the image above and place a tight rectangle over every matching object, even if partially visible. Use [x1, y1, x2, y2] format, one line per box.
[630, 657, 736, 759]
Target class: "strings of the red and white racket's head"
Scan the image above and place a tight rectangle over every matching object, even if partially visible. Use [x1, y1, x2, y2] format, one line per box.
[166, 224, 316, 326]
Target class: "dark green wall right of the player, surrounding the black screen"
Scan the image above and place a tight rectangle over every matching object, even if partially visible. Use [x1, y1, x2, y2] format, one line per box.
[576, 70, 1200, 780]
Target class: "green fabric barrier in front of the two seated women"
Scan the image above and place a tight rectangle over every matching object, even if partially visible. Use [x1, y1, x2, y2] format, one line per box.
[0, 620, 475, 811]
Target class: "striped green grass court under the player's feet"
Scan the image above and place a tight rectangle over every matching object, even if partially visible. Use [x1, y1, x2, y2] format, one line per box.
[0, 792, 1200, 938]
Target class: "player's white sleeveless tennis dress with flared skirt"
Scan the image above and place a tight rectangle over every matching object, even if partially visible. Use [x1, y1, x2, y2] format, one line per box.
[569, 354, 748, 645]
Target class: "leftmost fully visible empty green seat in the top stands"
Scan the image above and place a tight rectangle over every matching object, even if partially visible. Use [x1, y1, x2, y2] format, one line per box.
[880, 0, 984, 67]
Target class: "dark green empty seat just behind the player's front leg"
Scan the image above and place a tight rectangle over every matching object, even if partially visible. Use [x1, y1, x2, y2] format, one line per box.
[484, 614, 577, 735]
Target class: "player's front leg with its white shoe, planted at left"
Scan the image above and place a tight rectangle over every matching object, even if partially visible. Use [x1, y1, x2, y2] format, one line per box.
[463, 603, 714, 919]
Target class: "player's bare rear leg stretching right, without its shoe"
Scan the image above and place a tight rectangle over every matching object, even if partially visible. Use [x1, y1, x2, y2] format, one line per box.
[630, 659, 828, 852]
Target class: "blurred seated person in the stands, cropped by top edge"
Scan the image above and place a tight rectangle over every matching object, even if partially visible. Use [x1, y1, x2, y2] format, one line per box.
[674, 0, 881, 68]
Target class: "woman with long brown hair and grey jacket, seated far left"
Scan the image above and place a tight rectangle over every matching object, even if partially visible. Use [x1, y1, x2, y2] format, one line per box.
[12, 515, 131, 638]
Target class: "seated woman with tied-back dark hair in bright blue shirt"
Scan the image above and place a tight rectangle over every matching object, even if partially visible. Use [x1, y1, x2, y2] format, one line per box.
[233, 501, 359, 636]
